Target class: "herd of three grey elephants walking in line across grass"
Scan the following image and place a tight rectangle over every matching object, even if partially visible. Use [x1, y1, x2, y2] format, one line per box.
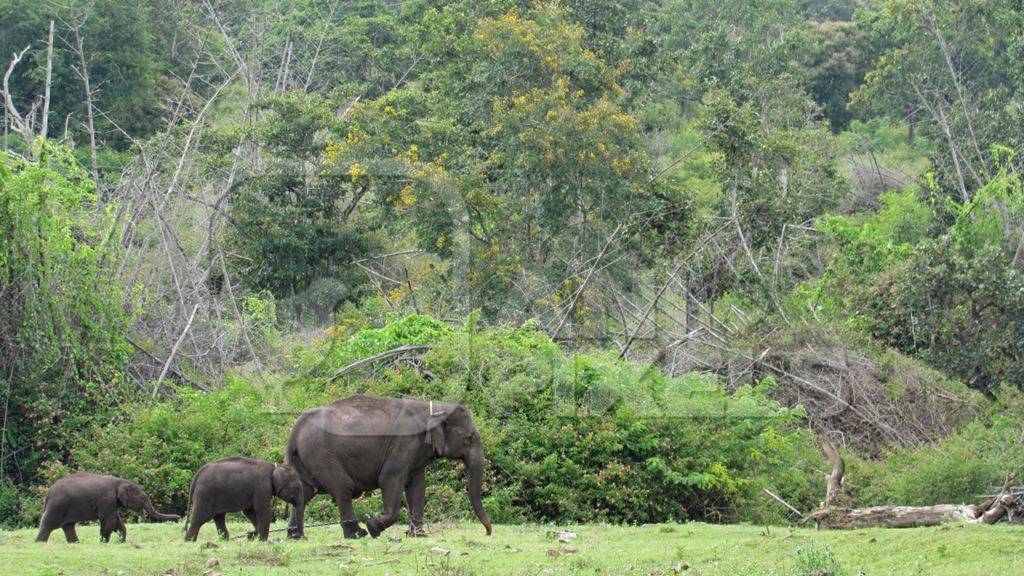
[36, 396, 490, 542]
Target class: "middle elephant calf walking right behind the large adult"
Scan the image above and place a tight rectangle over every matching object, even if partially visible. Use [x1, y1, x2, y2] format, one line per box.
[185, 457, 305, 542]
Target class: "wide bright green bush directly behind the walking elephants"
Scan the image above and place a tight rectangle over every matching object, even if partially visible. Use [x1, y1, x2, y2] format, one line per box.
[61, 316, 820, 523]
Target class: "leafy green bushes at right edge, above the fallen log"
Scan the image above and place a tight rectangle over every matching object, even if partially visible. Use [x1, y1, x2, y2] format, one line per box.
[811, 167, 1024, 393]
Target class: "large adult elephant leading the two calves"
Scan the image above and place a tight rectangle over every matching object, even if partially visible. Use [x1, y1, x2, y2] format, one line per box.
[285, 396, 490, 538]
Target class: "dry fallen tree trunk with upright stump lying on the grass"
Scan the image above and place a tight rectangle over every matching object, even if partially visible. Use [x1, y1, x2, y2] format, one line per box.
[804, 440, 1024, 530]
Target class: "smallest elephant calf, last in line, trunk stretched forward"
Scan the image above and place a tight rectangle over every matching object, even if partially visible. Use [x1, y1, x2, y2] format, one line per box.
[36, 472, 180, 542]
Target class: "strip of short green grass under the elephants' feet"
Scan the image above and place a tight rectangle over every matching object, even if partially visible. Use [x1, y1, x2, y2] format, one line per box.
[0, 524, 1024, 576]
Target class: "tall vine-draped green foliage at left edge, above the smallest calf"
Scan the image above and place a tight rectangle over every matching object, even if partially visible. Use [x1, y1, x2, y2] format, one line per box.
[0, 141, 134, 482]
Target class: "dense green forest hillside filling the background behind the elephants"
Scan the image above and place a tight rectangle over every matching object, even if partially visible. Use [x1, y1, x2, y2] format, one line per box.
[0, 0, 1024, 527]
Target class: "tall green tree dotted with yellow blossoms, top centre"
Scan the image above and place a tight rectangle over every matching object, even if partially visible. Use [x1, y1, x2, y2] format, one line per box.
[338, 3, 688, 318]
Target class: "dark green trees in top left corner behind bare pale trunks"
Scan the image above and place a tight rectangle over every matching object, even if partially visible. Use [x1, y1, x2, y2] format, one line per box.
[0, 0, 208, 158]
